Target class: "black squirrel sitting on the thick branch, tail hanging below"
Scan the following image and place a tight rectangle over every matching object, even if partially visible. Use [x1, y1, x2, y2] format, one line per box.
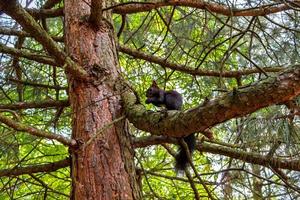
[146, 81, 196, 171]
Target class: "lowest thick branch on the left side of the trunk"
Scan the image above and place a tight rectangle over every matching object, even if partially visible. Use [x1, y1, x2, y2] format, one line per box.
[0, 158, 71, 177]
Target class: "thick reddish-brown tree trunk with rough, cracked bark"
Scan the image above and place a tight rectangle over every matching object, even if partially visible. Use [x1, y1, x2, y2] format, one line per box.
[65, 0, 140, 200]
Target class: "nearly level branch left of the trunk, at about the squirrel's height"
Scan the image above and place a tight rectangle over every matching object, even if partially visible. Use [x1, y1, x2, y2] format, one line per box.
[0, 100, 70, 110]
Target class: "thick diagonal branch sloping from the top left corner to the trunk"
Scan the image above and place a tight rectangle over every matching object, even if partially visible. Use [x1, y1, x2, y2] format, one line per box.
[0, 0, 88, 79]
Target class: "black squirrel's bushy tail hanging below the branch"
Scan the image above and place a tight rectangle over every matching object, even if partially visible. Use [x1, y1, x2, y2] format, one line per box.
[175, 134, 196, 171]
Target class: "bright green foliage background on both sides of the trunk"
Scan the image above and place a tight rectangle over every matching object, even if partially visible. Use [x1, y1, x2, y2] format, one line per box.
[0, 0, 300, 200]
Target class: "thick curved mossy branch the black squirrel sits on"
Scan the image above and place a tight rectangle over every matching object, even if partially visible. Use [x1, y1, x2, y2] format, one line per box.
[122, 65, 300, 137]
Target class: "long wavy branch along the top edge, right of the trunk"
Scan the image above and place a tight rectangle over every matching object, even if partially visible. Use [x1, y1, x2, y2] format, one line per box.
[113, 0, 291, 16]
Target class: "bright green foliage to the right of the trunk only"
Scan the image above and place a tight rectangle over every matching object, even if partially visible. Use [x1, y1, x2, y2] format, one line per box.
[114, 1, 299, 199]
